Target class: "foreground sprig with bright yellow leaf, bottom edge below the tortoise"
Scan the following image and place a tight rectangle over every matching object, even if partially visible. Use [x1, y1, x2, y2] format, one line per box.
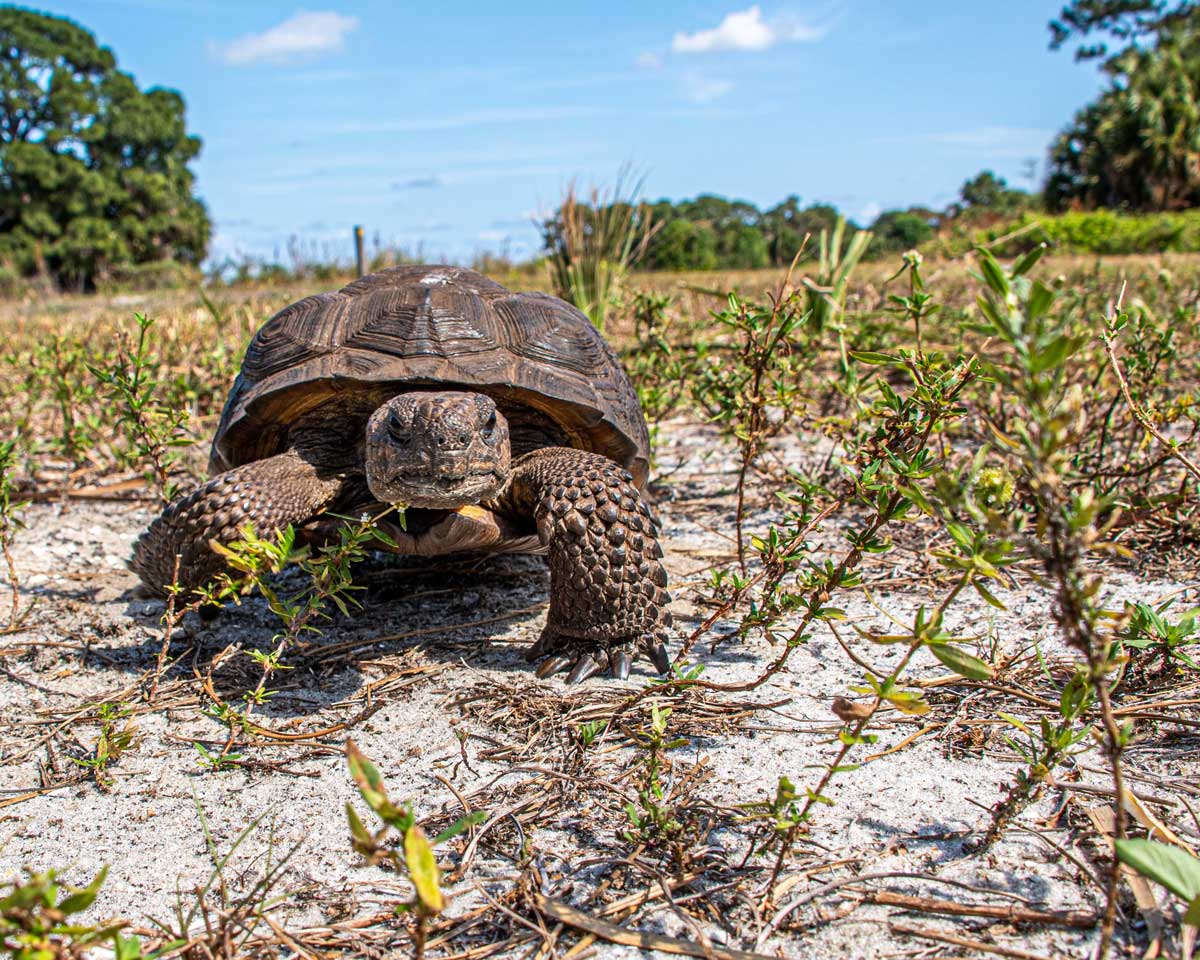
[346, 740, 487, 958]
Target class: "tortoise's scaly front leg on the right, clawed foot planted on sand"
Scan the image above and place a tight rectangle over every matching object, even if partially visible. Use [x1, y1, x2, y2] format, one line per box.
[509, 446, 671, 683]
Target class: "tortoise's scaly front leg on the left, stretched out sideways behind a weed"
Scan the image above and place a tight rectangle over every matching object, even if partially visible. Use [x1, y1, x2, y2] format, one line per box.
[130, 451, 343, 596]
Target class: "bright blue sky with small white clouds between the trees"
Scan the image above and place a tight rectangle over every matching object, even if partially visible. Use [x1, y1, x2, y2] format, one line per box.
[49, 0, 1102, 262]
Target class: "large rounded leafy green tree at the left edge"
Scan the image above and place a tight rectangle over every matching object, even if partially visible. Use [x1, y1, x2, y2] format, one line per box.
[0, 7, 211, 289]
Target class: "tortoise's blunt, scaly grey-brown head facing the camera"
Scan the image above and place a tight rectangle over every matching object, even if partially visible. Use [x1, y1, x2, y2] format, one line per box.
[366, 391, 511, 510]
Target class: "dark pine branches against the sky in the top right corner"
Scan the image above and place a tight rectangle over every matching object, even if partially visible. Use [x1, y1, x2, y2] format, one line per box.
[1050, 0, 1200, 60]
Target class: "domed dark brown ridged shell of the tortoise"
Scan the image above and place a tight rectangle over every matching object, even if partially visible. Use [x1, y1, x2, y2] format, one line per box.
[209, 266, 649, 487]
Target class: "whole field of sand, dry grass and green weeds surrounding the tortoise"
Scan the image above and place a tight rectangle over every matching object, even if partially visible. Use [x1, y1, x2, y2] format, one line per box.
[0, 254, 1200, 958]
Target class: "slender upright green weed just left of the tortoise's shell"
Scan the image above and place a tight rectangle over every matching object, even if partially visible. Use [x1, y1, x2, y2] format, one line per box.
[89, 313, 192, 503]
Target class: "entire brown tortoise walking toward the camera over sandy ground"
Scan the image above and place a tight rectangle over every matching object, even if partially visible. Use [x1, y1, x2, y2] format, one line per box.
[130, 265, 671, 683]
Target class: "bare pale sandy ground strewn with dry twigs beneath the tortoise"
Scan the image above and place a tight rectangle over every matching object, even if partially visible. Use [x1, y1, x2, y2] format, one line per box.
[0, 424, 1200, 958]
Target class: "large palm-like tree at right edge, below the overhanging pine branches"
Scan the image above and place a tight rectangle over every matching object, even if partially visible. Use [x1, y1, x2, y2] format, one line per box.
[1045, 26, 1200, 210]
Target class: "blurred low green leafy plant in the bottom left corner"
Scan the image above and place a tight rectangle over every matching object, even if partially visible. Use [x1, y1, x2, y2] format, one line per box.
[0, 866, 145, 960]
